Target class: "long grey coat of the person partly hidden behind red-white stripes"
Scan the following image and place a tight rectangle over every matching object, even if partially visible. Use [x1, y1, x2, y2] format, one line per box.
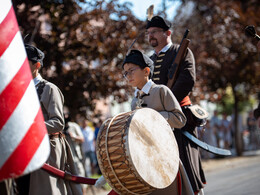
[29, 79, 82, 195]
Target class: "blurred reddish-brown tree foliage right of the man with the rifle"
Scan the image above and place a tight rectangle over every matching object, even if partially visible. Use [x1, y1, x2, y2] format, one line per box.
[174, 0, 260, 105]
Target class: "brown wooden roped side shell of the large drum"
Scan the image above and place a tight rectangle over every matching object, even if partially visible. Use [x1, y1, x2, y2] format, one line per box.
[96, 108, 179, 194]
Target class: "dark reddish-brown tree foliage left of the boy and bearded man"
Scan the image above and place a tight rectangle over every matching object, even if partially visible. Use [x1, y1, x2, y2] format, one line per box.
[13, 0, 145, 117]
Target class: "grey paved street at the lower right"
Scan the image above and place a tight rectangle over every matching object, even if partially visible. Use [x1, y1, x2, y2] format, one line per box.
[204, 151, 260, 195]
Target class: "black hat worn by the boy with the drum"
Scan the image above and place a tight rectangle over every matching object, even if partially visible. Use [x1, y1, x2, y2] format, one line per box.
[122, 49, 154, 77]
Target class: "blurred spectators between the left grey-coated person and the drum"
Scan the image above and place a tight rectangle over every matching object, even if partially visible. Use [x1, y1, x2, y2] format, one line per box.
[64, 113, 102, 192]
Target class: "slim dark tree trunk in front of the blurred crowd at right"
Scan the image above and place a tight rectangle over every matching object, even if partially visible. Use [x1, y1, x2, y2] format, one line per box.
[232, 87, 243, 156]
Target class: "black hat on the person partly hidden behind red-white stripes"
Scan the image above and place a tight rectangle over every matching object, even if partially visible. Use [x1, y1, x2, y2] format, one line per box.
[25, 44, 44, 66]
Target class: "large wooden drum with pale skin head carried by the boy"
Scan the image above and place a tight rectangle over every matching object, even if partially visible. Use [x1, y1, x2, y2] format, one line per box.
[96, 108, 179, 194]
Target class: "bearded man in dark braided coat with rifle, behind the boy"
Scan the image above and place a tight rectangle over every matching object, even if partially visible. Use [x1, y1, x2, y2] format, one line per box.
[146, 16, 206, 194]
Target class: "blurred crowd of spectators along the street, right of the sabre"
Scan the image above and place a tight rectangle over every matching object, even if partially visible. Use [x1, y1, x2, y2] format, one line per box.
[198, 111, 260, 159]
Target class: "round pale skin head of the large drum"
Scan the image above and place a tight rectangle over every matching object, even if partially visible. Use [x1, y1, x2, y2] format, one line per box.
[126, 108, 179, 189]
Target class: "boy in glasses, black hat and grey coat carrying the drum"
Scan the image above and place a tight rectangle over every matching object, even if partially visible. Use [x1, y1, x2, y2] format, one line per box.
[122, 50, 193, 195]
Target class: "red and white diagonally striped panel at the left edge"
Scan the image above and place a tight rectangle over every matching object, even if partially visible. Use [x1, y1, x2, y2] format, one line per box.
[0, 0, 50, 181]
